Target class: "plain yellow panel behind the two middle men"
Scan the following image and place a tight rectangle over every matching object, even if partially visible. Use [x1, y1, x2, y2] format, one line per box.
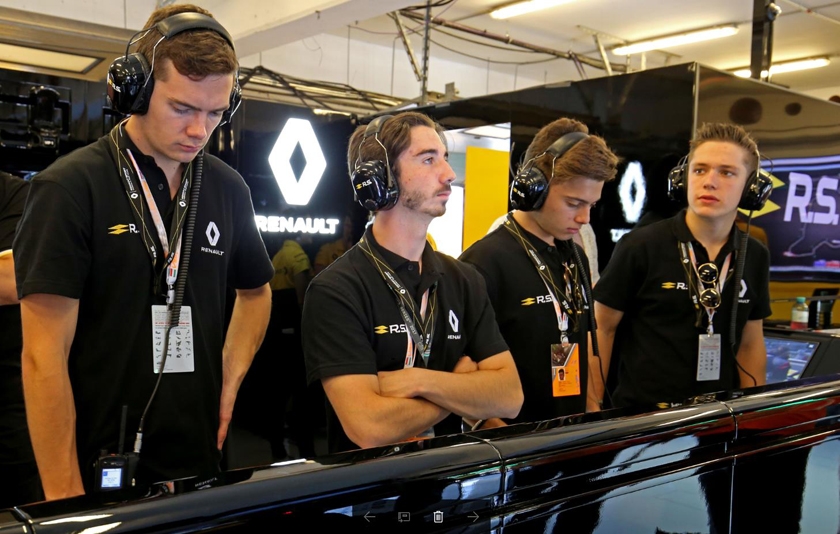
[463, 146, 510, 250]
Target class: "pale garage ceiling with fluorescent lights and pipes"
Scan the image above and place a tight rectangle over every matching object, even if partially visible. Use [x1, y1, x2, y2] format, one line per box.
[0, 0, 840, 96]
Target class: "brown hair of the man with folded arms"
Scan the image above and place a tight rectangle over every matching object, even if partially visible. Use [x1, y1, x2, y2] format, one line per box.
[347, 111, 446, 179]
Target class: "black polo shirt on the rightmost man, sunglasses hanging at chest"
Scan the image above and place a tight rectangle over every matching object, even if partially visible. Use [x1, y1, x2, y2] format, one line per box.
[594, 210, 770, 406]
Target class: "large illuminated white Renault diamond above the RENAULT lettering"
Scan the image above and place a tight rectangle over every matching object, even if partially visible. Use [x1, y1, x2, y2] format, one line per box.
[268, 119, 327, 206]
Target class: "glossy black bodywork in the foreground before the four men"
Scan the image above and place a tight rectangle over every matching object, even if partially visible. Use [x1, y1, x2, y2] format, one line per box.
[6, 377, 840, 534]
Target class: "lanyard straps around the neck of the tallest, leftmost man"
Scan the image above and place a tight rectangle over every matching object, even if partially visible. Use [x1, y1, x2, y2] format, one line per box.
[110, 121, 192, 298]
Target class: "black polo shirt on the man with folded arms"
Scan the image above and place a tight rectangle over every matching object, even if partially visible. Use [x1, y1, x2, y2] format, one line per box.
[302, 229, 508, 452]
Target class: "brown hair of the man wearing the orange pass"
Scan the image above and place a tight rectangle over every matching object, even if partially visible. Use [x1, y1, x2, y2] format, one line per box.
[525, 118, 619, 182]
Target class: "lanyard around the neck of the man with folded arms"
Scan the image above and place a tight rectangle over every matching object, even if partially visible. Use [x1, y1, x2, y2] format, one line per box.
[359, 236, 437, 367]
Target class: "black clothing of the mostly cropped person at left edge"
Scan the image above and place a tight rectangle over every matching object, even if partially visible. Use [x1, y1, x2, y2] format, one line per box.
[0, 172, 35, 464]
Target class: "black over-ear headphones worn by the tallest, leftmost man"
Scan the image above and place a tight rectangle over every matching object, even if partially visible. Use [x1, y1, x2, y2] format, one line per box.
[108, 12, 242, 124]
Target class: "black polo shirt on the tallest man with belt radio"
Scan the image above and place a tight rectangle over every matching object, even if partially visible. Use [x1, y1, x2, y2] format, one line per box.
[14, 135, 274, 486]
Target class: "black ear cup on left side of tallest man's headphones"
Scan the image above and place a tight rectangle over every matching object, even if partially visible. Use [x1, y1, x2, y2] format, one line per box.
[108, 53, 154, 115]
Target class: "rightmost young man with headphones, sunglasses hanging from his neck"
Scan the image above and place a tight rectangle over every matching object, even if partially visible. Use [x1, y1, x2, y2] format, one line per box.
[590, 123, 772, 412]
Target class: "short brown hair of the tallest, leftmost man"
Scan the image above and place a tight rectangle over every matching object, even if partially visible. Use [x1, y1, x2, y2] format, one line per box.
[137, 4, 239, 80]
